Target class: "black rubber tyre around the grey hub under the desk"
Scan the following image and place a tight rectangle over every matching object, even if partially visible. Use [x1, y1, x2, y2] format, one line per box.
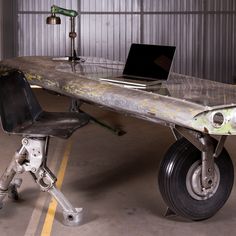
[158, 138, 234, 220]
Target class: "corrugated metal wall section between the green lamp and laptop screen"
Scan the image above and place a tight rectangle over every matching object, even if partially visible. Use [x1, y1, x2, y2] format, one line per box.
[81, 0, 141, 61]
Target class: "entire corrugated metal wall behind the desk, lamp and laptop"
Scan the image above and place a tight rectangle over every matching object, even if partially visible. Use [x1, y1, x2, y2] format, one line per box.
[4, 0, 236, 82]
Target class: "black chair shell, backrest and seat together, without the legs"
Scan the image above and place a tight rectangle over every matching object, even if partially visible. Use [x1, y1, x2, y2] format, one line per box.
[0, 70, 89, 139]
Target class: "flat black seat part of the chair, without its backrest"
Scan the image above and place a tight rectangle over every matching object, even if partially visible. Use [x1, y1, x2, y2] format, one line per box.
[10, 111, 89, 139]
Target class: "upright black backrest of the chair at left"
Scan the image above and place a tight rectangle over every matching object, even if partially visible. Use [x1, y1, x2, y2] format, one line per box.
[0, 70, 42, 133]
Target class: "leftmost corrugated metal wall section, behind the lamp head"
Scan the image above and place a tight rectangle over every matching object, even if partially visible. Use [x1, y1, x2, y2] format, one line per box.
[17, 0, 78, 56]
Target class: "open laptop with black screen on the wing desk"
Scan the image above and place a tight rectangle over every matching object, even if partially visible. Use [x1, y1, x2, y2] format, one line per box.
[100, 44, 176, 89]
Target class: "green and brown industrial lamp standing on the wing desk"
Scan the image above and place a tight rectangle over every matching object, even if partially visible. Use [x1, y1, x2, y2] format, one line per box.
[46, 5, 80, 61]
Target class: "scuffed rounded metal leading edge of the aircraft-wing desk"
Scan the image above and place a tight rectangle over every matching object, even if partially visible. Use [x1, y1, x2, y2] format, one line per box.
[0, 57, 212, 134]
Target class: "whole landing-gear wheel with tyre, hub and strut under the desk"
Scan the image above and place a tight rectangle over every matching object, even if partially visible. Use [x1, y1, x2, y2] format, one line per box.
[158, 130, 234, 220]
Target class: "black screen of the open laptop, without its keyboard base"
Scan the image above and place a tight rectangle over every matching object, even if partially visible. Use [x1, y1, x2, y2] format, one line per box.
[123, 44, 176, 80]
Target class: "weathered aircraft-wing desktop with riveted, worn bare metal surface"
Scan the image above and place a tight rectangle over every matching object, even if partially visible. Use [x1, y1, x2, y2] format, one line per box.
[1, 57, 236, 135]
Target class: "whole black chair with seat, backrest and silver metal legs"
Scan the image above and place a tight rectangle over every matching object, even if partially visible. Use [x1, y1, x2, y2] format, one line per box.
[0, 70, 89, 225]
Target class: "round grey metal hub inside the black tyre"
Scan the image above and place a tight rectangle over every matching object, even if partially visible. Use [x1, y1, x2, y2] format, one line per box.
[186, 160, 220, 200]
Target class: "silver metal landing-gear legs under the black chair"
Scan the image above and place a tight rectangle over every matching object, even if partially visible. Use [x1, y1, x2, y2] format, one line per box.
[0, 137, 83, 226]
